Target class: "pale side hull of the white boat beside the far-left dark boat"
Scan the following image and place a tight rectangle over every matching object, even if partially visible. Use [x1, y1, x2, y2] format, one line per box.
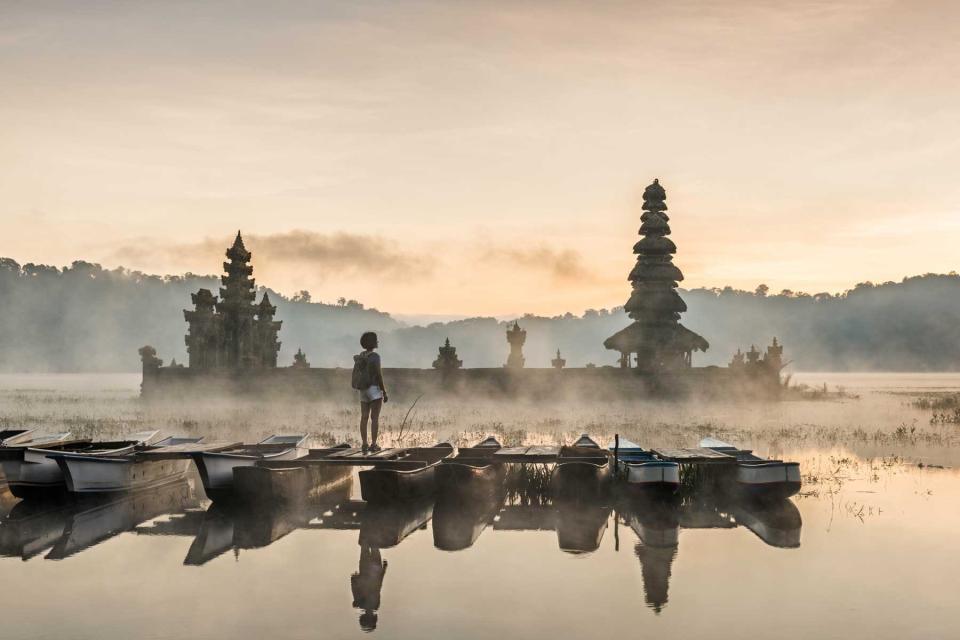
[55, 455, 190, 494]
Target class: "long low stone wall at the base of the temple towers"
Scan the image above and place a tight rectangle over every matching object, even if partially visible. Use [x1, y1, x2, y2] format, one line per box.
[142, 367, 779, 402]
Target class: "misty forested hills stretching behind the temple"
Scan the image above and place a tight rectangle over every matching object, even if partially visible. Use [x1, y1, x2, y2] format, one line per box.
[0, 258, 960, 372]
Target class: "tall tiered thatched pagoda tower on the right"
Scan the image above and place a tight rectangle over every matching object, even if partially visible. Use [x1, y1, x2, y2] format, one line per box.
[603, 180, 710, 372]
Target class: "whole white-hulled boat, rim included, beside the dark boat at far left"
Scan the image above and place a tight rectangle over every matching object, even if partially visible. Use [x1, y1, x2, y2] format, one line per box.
[48, 437, 211, 494]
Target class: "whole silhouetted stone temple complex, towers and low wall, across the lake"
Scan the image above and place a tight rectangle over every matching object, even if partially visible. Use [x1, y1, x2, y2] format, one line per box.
[140, 180, 785, 401]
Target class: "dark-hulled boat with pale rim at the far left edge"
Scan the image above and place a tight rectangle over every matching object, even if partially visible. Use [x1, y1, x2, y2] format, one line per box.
[0, 431, 158, 498]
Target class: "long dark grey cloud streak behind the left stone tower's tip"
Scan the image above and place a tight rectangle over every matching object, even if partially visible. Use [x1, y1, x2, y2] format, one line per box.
[112, 230, 434, 278]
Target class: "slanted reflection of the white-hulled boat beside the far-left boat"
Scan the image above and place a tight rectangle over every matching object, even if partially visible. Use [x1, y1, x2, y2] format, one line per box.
[46, 481, 199, 560]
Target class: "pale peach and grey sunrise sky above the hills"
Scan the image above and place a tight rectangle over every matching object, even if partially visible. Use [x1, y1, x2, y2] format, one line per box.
[0, 0, 960, 316]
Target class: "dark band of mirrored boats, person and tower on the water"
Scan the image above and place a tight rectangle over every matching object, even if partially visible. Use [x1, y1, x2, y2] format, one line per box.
[0, 466, 802, 631]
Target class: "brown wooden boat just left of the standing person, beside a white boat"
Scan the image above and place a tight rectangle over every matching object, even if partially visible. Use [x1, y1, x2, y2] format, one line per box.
[233, 444, 353, 505]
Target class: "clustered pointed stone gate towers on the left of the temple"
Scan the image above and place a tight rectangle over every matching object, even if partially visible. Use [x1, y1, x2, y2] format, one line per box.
[183, 231, 281, 369]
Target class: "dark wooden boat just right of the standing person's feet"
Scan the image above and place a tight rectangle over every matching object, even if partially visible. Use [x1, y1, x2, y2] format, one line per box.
[359, 442, 453, 503]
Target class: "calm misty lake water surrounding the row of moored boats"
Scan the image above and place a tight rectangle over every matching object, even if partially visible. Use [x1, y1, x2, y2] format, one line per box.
[0, 374, 960, 639]
